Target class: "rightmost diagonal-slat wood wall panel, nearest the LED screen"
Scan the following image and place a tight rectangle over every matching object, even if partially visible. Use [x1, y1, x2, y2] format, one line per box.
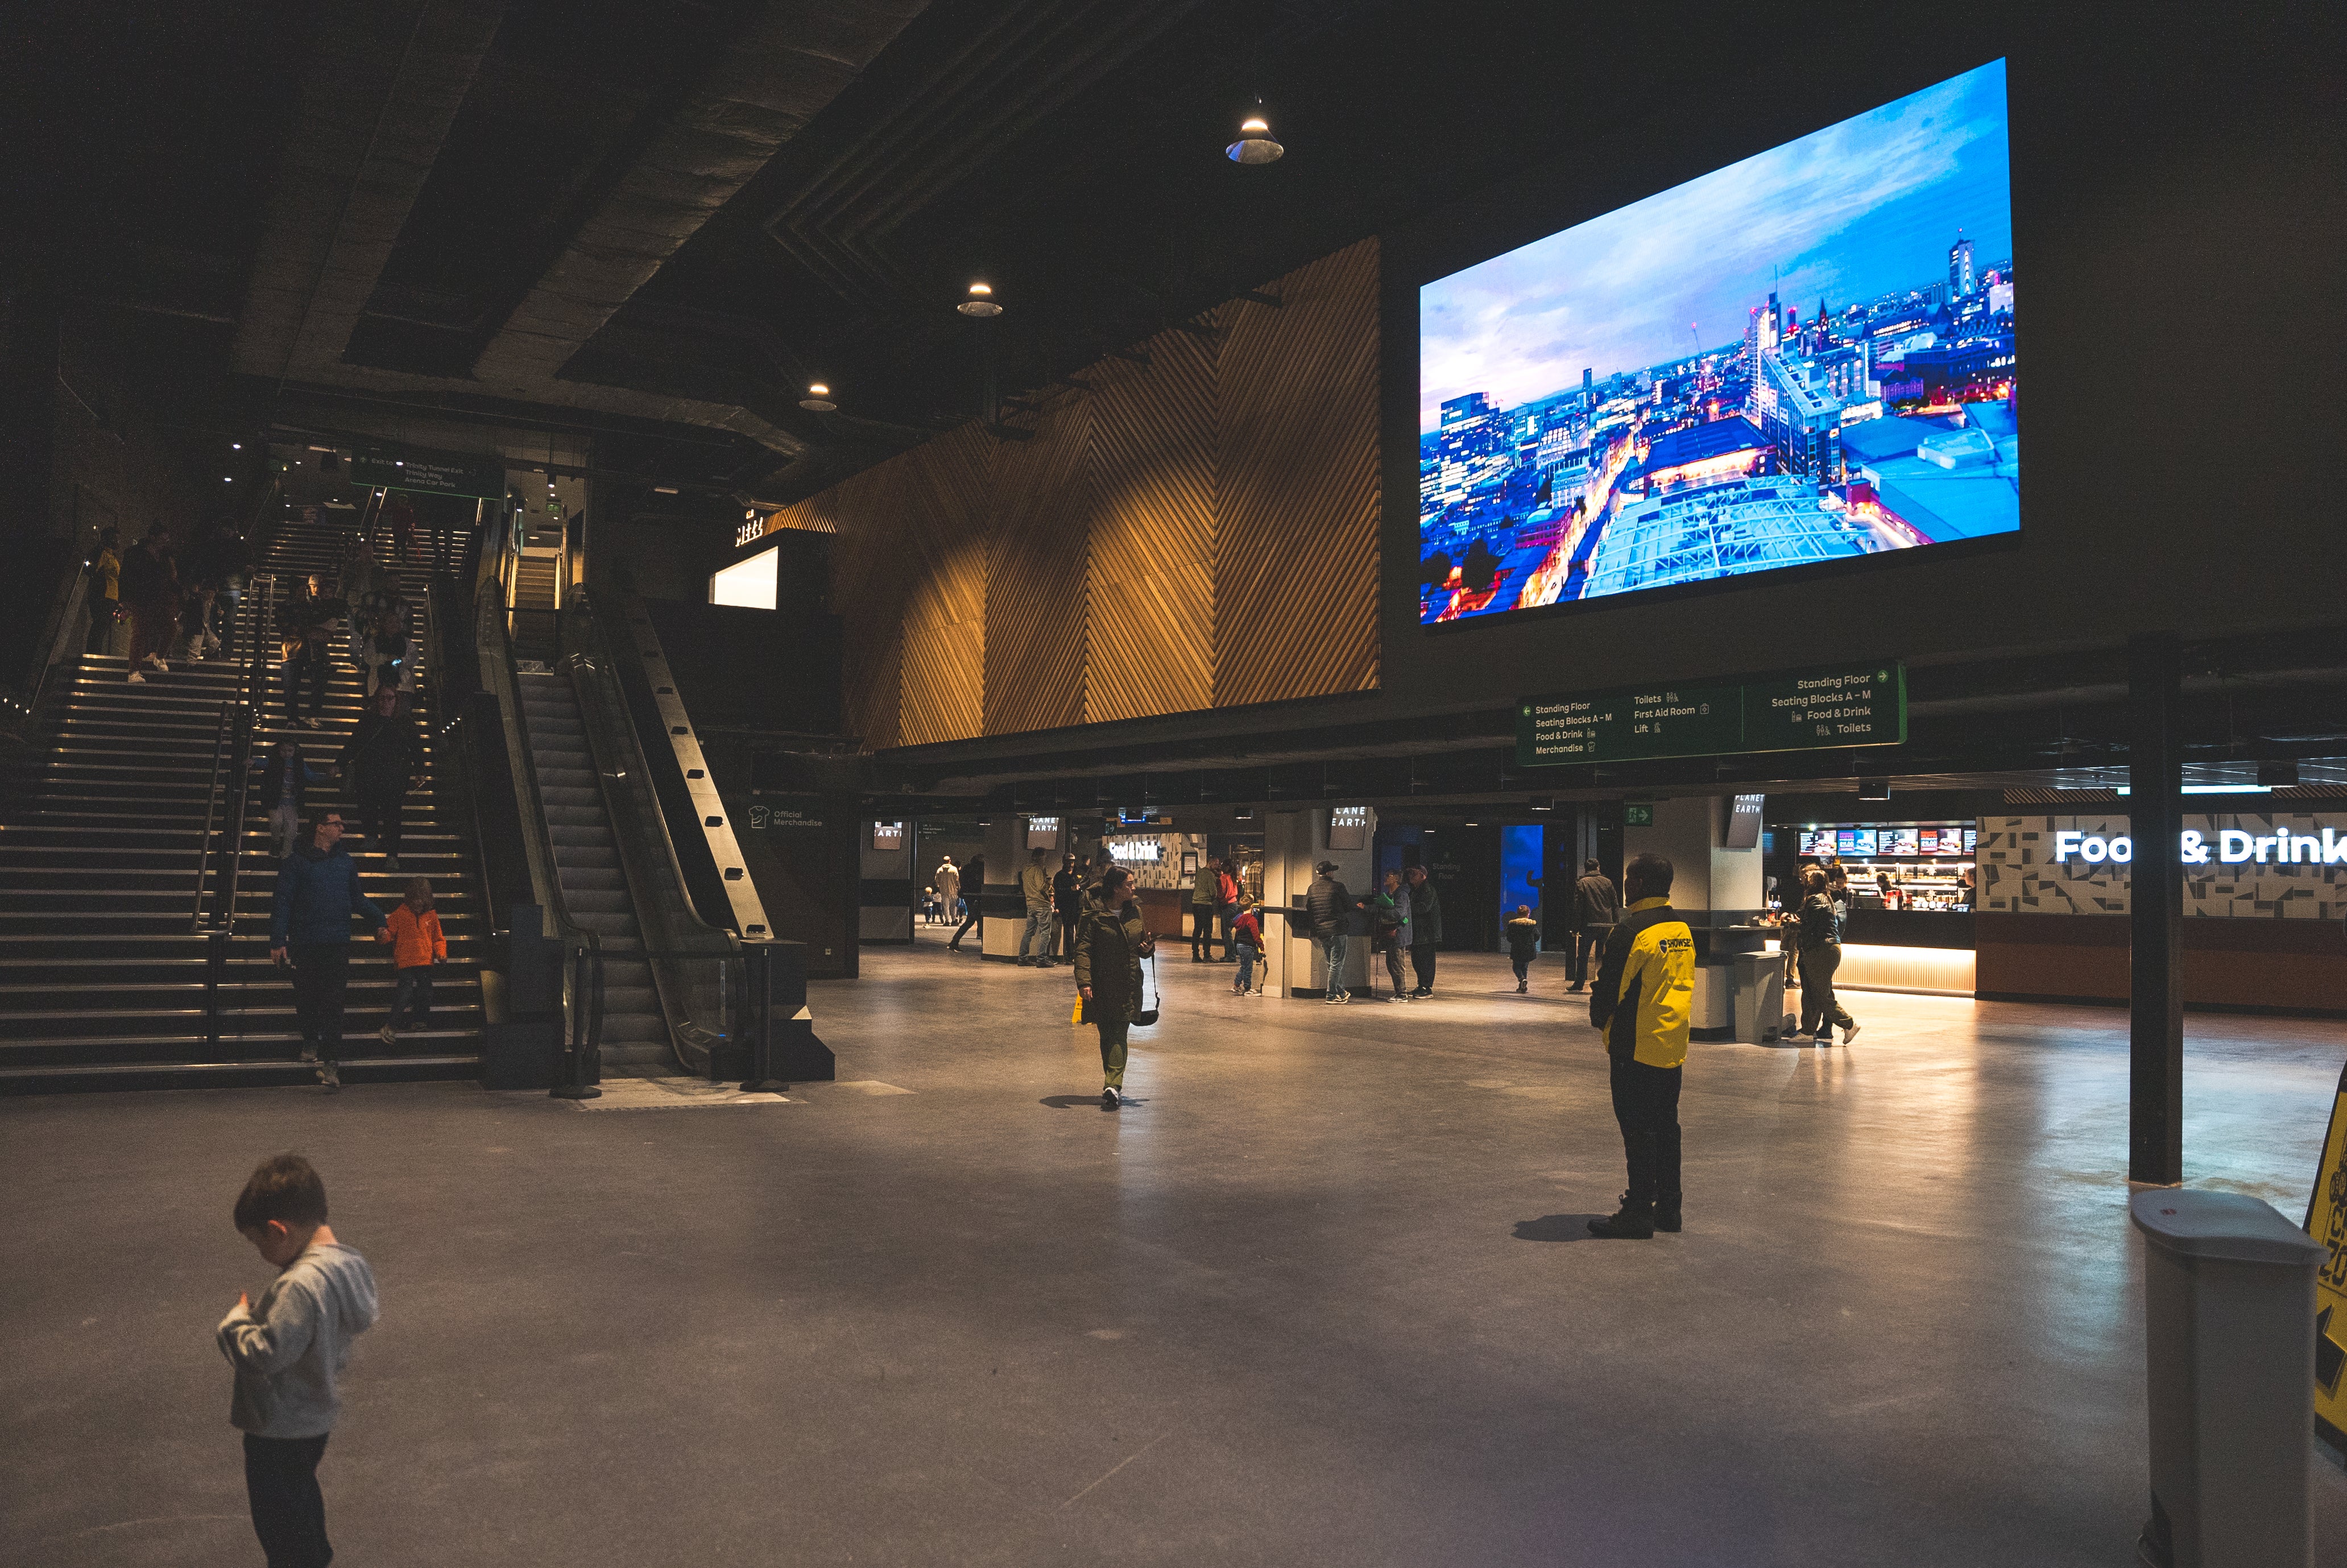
[1214, 239, 1378, 706]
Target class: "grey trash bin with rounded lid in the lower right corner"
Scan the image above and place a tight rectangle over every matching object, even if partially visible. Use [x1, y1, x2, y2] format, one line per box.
[2126, 1188, 2326, 1568]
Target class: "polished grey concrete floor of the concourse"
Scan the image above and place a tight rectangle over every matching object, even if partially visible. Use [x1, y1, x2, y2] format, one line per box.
[0, 944, 2347, 1568]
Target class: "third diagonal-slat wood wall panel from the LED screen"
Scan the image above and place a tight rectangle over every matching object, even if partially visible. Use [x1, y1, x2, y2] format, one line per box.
[983, 397, 1091, 735]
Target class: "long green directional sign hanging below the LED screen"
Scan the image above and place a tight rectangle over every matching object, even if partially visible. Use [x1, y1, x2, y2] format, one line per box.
[1516, 662, 1906, 768]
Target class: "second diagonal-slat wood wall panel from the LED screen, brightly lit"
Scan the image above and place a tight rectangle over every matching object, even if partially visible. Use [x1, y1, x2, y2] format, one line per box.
[1084, 331, 1216, 723]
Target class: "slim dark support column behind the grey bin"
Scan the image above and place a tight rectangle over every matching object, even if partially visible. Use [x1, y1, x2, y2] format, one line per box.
[2126, 631, 2185, 1188]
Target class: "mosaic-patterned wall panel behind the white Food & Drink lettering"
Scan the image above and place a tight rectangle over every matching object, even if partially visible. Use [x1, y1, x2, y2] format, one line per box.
[1978, 812, 2347, 920]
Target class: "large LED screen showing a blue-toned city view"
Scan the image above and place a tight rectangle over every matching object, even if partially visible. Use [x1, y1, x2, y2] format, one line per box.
[1418, 61, 2021, 622]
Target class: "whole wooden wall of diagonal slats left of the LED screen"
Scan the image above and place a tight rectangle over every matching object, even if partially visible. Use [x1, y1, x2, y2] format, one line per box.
[768, 239, 1378, 751]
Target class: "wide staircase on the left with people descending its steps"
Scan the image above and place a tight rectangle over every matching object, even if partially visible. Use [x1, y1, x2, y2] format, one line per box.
[0, 521, 483, 1091]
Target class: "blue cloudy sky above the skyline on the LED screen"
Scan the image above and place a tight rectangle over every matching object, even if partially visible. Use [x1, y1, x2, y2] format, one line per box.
[1418, 61, 2014, 429]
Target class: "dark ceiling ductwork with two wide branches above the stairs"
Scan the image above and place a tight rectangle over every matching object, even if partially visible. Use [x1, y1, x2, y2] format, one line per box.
[235, 0, 922, 467]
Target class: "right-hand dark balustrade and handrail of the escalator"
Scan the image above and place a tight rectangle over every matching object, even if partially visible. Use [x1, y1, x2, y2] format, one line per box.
[561, 585, 742, 1075]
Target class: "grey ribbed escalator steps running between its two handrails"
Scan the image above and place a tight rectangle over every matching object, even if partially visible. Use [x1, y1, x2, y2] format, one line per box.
[516, 674, 678, 1077]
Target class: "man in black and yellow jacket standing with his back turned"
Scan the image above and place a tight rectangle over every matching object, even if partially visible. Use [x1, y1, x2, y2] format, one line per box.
[1589, 854, 1695, 1242]
